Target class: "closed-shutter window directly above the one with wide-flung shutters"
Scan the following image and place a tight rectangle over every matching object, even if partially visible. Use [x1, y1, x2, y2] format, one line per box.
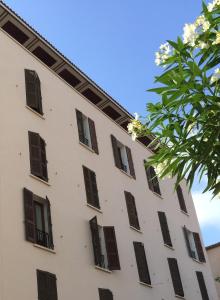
[83, 166, 100, 209]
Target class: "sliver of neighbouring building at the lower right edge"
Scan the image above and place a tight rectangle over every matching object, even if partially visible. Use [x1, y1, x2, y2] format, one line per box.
[206, 243, 220, 299]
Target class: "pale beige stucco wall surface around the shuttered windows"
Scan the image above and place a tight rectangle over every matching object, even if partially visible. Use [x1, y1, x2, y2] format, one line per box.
[0, 31, 217, 300]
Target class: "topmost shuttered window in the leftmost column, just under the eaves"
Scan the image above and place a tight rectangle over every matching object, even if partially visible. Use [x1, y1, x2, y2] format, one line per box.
[25, 70, 43, 115]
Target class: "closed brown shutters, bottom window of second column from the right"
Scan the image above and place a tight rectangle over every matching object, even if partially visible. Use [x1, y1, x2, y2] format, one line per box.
[167, 258, 184, 297]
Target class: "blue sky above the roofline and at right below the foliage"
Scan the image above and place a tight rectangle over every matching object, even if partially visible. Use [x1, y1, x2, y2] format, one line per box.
[5, 0, 220, 245]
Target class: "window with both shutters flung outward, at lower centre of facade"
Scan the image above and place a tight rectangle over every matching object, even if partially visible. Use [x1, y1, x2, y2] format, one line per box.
[89, 217, 120, 270]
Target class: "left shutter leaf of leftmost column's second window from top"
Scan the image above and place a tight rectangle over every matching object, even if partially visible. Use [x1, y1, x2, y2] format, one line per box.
[28, 131, 43, 178]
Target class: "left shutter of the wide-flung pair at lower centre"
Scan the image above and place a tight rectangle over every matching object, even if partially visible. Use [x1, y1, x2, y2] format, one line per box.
[89, 217, 104, 267]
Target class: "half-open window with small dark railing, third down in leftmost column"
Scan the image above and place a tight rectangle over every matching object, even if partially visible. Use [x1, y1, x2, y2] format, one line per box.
[23, 188, 54, 249]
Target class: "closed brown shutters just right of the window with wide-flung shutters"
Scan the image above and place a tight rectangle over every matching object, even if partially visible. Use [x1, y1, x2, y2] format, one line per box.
[133, 242, 151, 285]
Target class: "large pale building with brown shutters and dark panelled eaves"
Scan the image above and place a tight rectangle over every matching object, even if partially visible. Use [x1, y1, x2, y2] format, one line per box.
[0, 3, 218, 300]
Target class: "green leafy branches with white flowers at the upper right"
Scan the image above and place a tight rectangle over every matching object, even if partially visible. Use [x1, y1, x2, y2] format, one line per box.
[128, 0, 220, 196]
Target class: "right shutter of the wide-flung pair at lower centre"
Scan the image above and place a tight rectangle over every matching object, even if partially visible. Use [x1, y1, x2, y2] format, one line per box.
[103, 226, 121, 270]
